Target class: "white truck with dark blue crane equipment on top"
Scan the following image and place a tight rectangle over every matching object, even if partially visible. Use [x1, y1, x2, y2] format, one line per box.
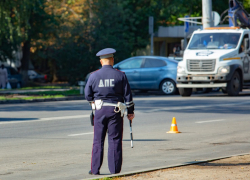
[177, 0, 250, 96]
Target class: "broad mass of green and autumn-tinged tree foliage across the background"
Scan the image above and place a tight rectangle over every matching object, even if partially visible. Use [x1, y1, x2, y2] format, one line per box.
[0, 0, 247, 83]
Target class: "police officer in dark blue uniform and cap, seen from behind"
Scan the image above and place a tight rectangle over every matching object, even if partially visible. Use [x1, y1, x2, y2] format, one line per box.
[85, 48, 134, 174]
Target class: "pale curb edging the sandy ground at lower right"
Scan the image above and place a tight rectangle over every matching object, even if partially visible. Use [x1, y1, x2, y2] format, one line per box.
[82, 153, 250, 180]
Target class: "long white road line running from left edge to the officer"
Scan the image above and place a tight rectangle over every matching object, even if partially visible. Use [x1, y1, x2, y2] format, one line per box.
[0, 115, 89, 124]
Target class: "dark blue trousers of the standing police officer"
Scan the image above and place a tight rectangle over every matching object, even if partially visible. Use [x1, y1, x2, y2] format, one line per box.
[91, 106, 123, 174]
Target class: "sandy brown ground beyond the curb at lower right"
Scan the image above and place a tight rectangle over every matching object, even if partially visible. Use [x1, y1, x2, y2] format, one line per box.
[94, 154, 250, 180]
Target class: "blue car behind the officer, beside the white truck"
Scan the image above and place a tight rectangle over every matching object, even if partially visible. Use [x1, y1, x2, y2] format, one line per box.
[85, 56, 178, 94]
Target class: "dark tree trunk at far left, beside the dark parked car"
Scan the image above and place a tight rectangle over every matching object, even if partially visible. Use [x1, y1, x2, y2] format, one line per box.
[21, 40, 30, 86]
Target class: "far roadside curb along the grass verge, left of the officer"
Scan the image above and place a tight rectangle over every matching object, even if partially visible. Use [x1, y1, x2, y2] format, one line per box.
[0, 96, 85, 104]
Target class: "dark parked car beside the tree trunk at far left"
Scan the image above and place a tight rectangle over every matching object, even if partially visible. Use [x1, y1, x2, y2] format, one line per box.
[6, 67, 22, 88]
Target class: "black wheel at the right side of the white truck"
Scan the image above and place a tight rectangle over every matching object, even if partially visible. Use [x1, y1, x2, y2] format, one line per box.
[227, 71, 241, 96]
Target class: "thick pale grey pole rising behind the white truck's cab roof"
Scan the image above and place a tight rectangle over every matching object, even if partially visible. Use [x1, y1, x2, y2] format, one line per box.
[202, 0, 213, 29]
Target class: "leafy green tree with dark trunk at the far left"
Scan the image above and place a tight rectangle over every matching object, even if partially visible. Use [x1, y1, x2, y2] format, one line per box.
[0, 0, 53, 83]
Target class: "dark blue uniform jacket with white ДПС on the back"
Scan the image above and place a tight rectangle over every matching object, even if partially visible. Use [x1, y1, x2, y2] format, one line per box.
[85, 65, 134, 114]
